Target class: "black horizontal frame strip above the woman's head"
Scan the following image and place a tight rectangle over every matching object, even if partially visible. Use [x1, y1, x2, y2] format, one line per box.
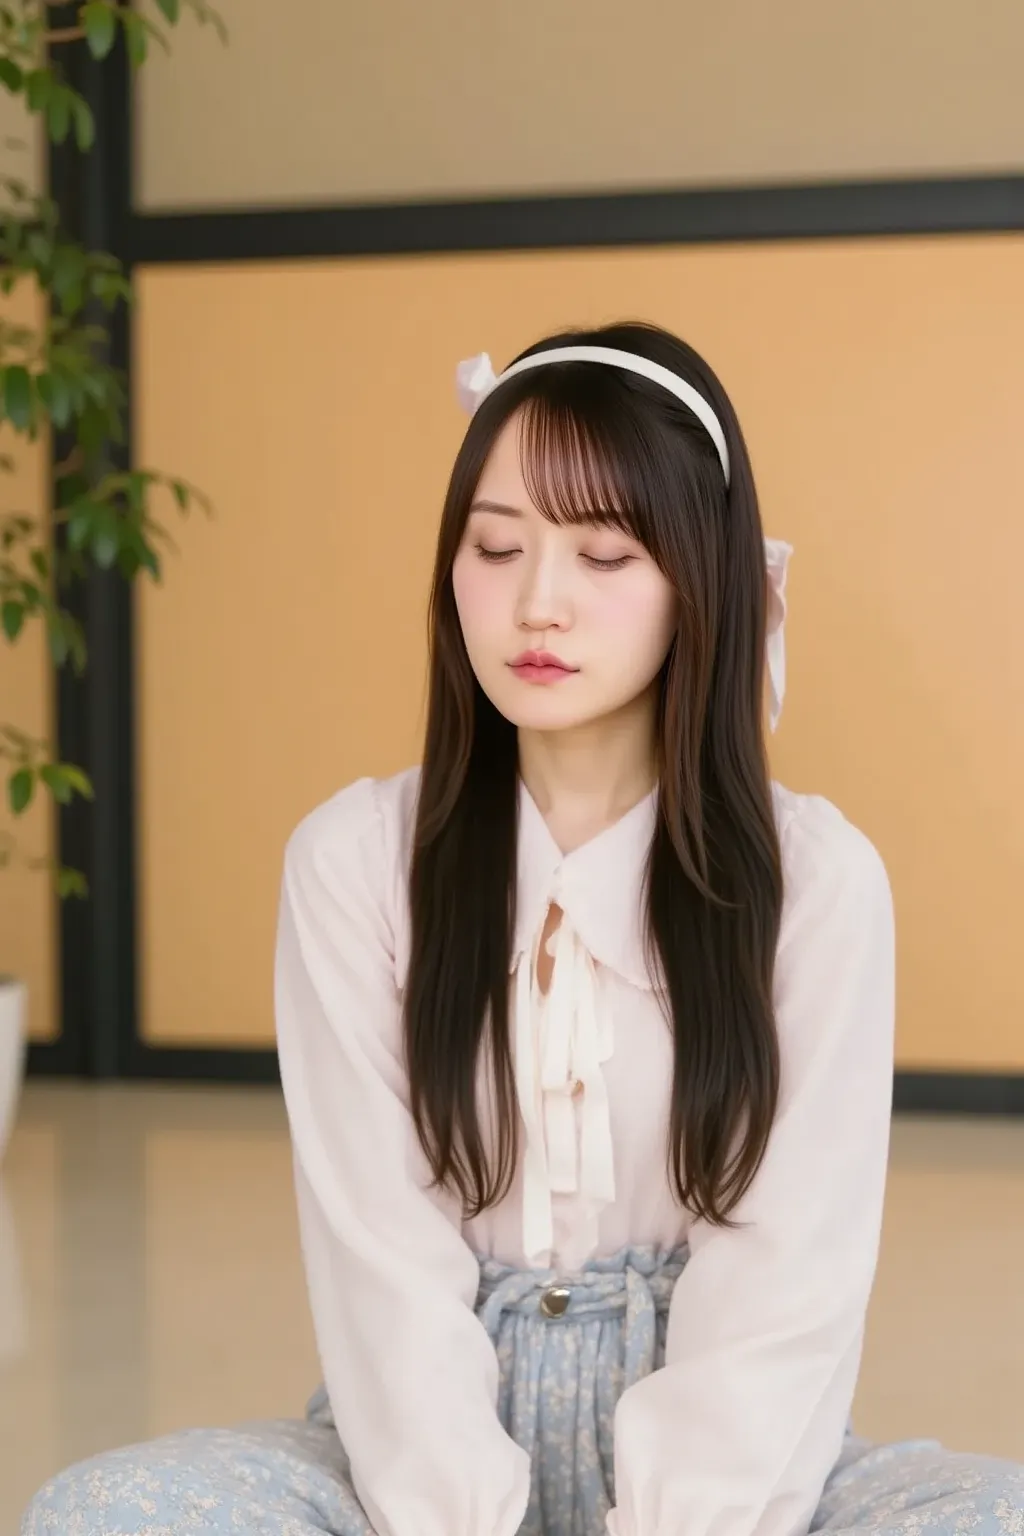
[129, 175, 1024, 264]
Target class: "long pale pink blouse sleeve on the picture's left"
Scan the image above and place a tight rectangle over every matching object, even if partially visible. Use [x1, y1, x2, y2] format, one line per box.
[275, 780, 530, 1536]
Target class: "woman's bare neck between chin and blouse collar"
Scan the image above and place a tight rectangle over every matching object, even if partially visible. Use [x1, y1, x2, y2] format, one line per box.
[519, 687, 657, 852]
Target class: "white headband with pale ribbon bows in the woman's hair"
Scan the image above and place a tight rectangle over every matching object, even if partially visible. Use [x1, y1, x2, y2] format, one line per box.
[454, 347, 792, 731]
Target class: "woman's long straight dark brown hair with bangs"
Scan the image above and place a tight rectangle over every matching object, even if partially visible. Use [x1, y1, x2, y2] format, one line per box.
[404, 324, 783, 1226]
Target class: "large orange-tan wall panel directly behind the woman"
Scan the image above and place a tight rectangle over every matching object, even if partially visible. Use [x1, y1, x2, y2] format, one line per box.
[137, 237, 1024, 1069]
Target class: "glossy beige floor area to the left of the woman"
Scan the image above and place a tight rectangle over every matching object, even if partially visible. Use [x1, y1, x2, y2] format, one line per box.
[0, 1084, 318, 1536]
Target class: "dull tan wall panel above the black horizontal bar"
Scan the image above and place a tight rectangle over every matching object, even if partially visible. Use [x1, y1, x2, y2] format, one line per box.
[137, 0, 1024, 209]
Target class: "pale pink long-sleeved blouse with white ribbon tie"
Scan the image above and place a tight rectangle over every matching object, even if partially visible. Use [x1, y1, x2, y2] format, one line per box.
[276, 771, 894, 1536]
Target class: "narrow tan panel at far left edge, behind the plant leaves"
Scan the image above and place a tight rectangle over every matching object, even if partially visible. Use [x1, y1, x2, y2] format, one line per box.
[0, 292, 58, 1040]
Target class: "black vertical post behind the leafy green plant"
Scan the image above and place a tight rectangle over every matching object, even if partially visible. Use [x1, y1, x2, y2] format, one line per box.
[31, 18, 135, 1078]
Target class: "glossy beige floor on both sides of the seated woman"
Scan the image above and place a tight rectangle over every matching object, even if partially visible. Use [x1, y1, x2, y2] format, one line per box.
[0, 1084, 1024, 1536]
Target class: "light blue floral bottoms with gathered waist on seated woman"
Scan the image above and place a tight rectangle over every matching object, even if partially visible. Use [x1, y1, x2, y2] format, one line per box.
[21, 1249, 1024, 1536]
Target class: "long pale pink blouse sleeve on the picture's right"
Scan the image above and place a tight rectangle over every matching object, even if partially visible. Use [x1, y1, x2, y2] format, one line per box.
[609, 800, 895, 1536]
